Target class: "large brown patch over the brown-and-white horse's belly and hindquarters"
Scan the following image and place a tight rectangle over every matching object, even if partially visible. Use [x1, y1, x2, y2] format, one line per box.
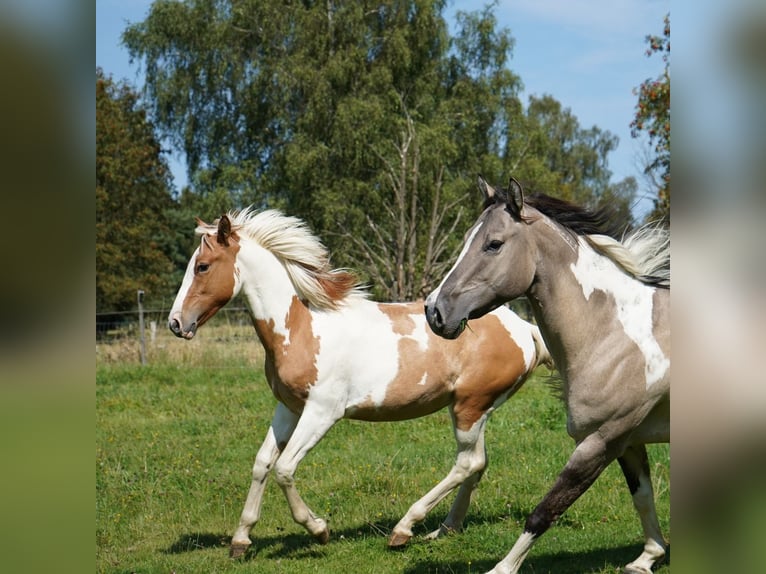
[353, 303, 527, 430]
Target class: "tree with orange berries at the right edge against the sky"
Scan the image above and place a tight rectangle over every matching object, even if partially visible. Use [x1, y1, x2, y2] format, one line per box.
[630, 14, 670, 225]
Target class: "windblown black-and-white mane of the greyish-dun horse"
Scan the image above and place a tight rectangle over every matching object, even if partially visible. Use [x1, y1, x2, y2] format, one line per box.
[525, 194, 670, 287]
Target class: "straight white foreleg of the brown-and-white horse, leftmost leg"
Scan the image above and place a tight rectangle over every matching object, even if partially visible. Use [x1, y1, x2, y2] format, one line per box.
[229, 403, 298, 558]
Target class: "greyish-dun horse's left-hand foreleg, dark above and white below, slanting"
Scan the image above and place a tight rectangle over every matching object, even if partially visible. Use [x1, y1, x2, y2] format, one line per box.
[488, 433, 614, 574]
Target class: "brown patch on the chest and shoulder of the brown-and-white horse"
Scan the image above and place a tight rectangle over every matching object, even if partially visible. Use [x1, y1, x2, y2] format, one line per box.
[254, 296, 320, 413]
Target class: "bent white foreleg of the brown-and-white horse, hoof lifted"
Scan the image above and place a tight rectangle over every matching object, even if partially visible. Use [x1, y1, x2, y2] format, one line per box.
[274, 404, 341, 544]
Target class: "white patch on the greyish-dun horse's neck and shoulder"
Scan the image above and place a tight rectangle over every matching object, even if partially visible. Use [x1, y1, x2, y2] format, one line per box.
[571, 240, 670, 388]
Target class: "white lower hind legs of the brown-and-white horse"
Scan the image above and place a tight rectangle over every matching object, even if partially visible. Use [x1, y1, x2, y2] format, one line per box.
[388, 415, 487, 548]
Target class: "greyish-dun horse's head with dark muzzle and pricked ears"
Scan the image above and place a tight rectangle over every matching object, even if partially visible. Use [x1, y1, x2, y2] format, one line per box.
[425, 177, 535, 339]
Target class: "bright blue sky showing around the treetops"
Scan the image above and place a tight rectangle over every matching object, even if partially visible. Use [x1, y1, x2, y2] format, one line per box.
[96, 0, 670, 216]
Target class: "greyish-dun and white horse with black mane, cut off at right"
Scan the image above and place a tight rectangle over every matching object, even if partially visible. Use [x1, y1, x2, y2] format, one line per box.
[425, 177, 670, 574]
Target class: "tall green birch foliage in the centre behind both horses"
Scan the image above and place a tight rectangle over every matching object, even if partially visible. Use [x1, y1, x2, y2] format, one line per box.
[123, 0, 633, 300]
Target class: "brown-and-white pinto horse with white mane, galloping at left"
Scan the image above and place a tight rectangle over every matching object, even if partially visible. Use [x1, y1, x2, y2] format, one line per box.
[168, 208, 550, 558]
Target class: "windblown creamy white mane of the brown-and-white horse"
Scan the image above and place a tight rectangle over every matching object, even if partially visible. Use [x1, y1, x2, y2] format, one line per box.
[196, 207, 367, 310]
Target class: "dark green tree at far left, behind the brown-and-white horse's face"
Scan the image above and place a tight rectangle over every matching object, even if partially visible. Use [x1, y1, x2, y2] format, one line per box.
[96, 68, 179, 320]
